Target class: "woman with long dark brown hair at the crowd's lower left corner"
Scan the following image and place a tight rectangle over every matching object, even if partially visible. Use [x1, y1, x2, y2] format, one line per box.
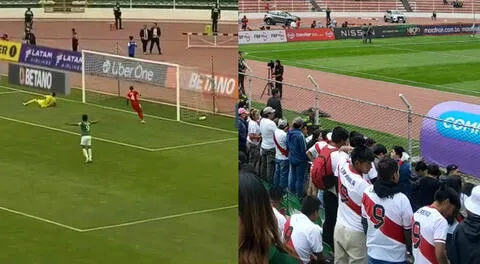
[238, 166, 299, 264]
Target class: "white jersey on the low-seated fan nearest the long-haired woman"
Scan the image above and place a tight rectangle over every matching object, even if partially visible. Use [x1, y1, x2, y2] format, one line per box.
[283, 213, 323, 263]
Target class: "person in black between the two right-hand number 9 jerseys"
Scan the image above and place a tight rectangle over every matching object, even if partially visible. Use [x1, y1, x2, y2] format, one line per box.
[412, 165, 440, 211]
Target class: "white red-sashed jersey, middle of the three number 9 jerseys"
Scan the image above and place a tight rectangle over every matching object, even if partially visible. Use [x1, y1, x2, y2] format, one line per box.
[362, 186, 413, 262]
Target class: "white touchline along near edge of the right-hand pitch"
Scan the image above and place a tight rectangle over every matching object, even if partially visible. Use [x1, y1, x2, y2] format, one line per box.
[250, 56, 480, 98]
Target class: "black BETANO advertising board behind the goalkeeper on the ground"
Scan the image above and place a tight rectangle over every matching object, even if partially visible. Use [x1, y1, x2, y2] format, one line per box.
[8, 64, 70, 95]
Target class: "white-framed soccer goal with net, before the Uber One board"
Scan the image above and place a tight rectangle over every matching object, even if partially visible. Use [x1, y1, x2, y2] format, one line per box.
[82, 50, 215, 121]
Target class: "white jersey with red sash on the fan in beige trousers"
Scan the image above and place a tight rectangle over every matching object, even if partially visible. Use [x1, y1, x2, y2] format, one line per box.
[337, 163, 369, 232]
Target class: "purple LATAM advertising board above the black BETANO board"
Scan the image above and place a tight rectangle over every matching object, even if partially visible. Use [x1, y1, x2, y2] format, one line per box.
[20, 44, 82, 72]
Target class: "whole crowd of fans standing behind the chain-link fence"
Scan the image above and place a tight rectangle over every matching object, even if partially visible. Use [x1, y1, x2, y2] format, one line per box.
[238, 100, 480, 264]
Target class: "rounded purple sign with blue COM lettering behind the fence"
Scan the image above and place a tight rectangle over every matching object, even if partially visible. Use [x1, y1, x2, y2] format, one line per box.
[420, 101, 480, 178]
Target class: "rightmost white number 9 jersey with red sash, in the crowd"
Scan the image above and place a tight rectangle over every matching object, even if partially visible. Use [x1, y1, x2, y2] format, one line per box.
[412, 206, 448, 264]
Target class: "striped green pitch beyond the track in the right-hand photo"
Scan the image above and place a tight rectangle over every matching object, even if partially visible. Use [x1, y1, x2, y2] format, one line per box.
[240, 35, 480, 96]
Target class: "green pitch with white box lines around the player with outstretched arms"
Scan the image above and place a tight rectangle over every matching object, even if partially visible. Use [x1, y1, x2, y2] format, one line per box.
[0, 82, 237, 264]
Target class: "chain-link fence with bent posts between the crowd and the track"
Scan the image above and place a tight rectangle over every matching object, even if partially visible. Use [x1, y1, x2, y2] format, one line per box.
[244, 73, 480, 178]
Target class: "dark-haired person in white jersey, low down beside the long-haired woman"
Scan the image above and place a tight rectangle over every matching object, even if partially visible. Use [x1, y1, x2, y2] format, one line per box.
[283, 196, 325, 264]
